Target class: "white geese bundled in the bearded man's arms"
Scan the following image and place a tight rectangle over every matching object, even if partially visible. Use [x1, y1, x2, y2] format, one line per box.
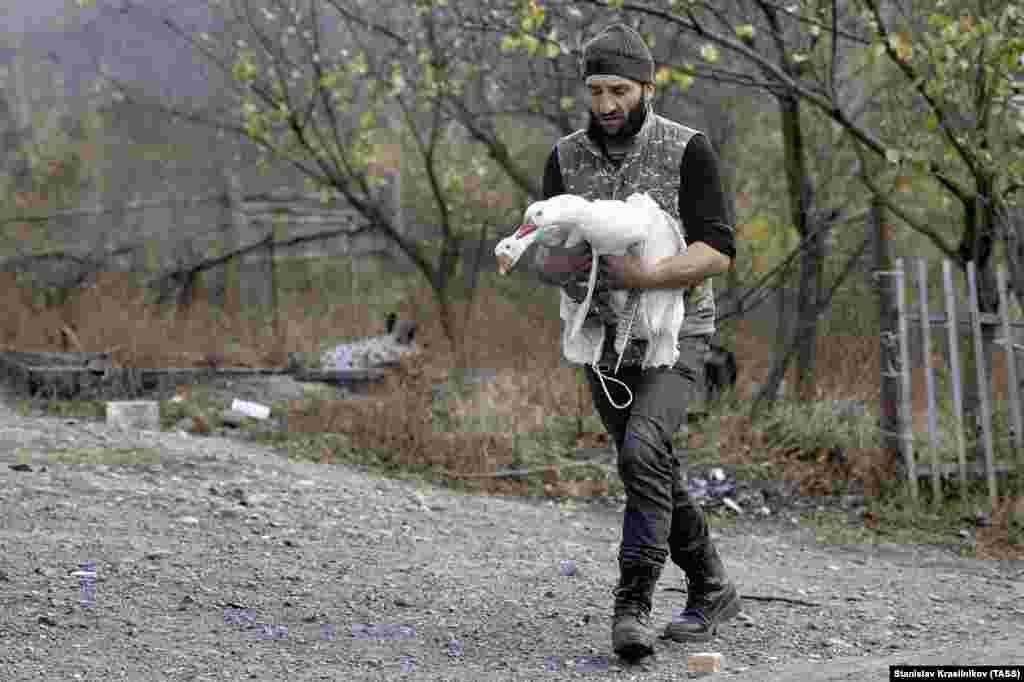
[495, 194, 686, 408]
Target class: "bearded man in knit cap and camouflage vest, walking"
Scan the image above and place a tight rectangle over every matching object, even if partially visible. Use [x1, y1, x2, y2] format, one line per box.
[534, 25, 740, 659]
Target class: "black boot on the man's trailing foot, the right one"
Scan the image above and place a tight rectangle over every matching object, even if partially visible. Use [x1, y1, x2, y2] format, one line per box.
[665, 507, 741, 642]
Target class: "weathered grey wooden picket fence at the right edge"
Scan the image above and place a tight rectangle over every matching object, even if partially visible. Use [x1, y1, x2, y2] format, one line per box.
[880, 258, 1024, 508]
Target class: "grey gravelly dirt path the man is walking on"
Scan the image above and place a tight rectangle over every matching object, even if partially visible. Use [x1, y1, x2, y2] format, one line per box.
[0, 414, 1024, 681]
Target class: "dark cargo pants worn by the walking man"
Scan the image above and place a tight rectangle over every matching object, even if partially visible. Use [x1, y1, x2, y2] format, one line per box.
[587, 330, 724, 584]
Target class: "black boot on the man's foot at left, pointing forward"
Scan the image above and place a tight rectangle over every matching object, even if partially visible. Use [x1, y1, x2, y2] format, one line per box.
[611, 563, 662, 660]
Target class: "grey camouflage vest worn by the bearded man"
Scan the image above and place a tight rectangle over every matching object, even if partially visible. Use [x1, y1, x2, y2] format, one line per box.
[556, 110, 715, 338]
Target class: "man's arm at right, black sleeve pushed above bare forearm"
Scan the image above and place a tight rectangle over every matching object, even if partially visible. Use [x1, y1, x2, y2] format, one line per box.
[602, 134, 736, 289]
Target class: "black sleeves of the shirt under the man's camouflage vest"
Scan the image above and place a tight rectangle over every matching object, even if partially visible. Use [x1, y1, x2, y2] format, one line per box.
[542, 134, 736, 258]
